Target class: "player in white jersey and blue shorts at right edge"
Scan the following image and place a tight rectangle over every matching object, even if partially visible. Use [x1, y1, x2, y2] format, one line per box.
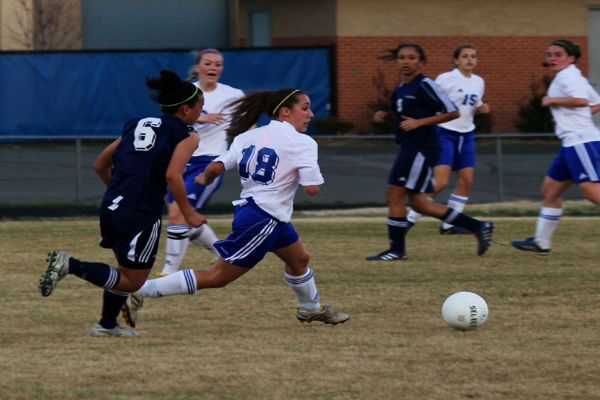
[512, 39, 600, 255]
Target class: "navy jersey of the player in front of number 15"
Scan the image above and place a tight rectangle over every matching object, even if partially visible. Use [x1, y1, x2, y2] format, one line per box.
[391, 74, 458, 147]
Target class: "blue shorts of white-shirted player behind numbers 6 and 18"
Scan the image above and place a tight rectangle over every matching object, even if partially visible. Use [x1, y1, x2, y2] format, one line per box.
[167, 156, 223, 210]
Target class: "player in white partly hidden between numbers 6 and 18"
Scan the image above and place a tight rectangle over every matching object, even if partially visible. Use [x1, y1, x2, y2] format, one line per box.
[158, 49, 244, 276]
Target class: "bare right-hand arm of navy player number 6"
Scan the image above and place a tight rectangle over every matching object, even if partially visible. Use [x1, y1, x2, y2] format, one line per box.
[166, 135, 206, 227]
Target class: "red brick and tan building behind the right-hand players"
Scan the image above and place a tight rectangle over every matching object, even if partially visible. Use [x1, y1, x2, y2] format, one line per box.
[239, 0, 600, 132]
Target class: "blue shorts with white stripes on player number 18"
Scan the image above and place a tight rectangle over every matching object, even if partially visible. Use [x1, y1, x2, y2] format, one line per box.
[214, 198, 300, 268]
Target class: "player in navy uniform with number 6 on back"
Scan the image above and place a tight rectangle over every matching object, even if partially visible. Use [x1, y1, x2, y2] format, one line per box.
[39, 70, 206, 336]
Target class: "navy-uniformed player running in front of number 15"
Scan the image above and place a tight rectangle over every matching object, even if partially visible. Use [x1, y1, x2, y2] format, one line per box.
[366, 44, 494, 261]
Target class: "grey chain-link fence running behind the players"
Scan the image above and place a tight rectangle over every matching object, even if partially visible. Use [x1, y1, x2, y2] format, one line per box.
[0, 134, 580, 216]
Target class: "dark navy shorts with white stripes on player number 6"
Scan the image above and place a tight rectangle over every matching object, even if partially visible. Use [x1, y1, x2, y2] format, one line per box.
[100, 203, 161, 269]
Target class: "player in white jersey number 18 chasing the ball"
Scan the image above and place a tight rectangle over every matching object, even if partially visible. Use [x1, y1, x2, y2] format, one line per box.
[123, 88, 349, 325]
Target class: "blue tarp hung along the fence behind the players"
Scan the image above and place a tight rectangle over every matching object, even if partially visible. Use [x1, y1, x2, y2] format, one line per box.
[0, 48, 331, 139]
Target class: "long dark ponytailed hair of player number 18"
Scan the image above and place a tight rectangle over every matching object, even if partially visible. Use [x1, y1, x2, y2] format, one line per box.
[227, 88, 304, 143]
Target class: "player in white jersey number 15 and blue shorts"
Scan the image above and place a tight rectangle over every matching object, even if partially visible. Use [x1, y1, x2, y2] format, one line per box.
[407, 44, 490, 235]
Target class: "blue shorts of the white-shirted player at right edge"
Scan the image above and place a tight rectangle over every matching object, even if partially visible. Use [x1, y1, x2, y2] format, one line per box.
[547, 142, 600, 184]
